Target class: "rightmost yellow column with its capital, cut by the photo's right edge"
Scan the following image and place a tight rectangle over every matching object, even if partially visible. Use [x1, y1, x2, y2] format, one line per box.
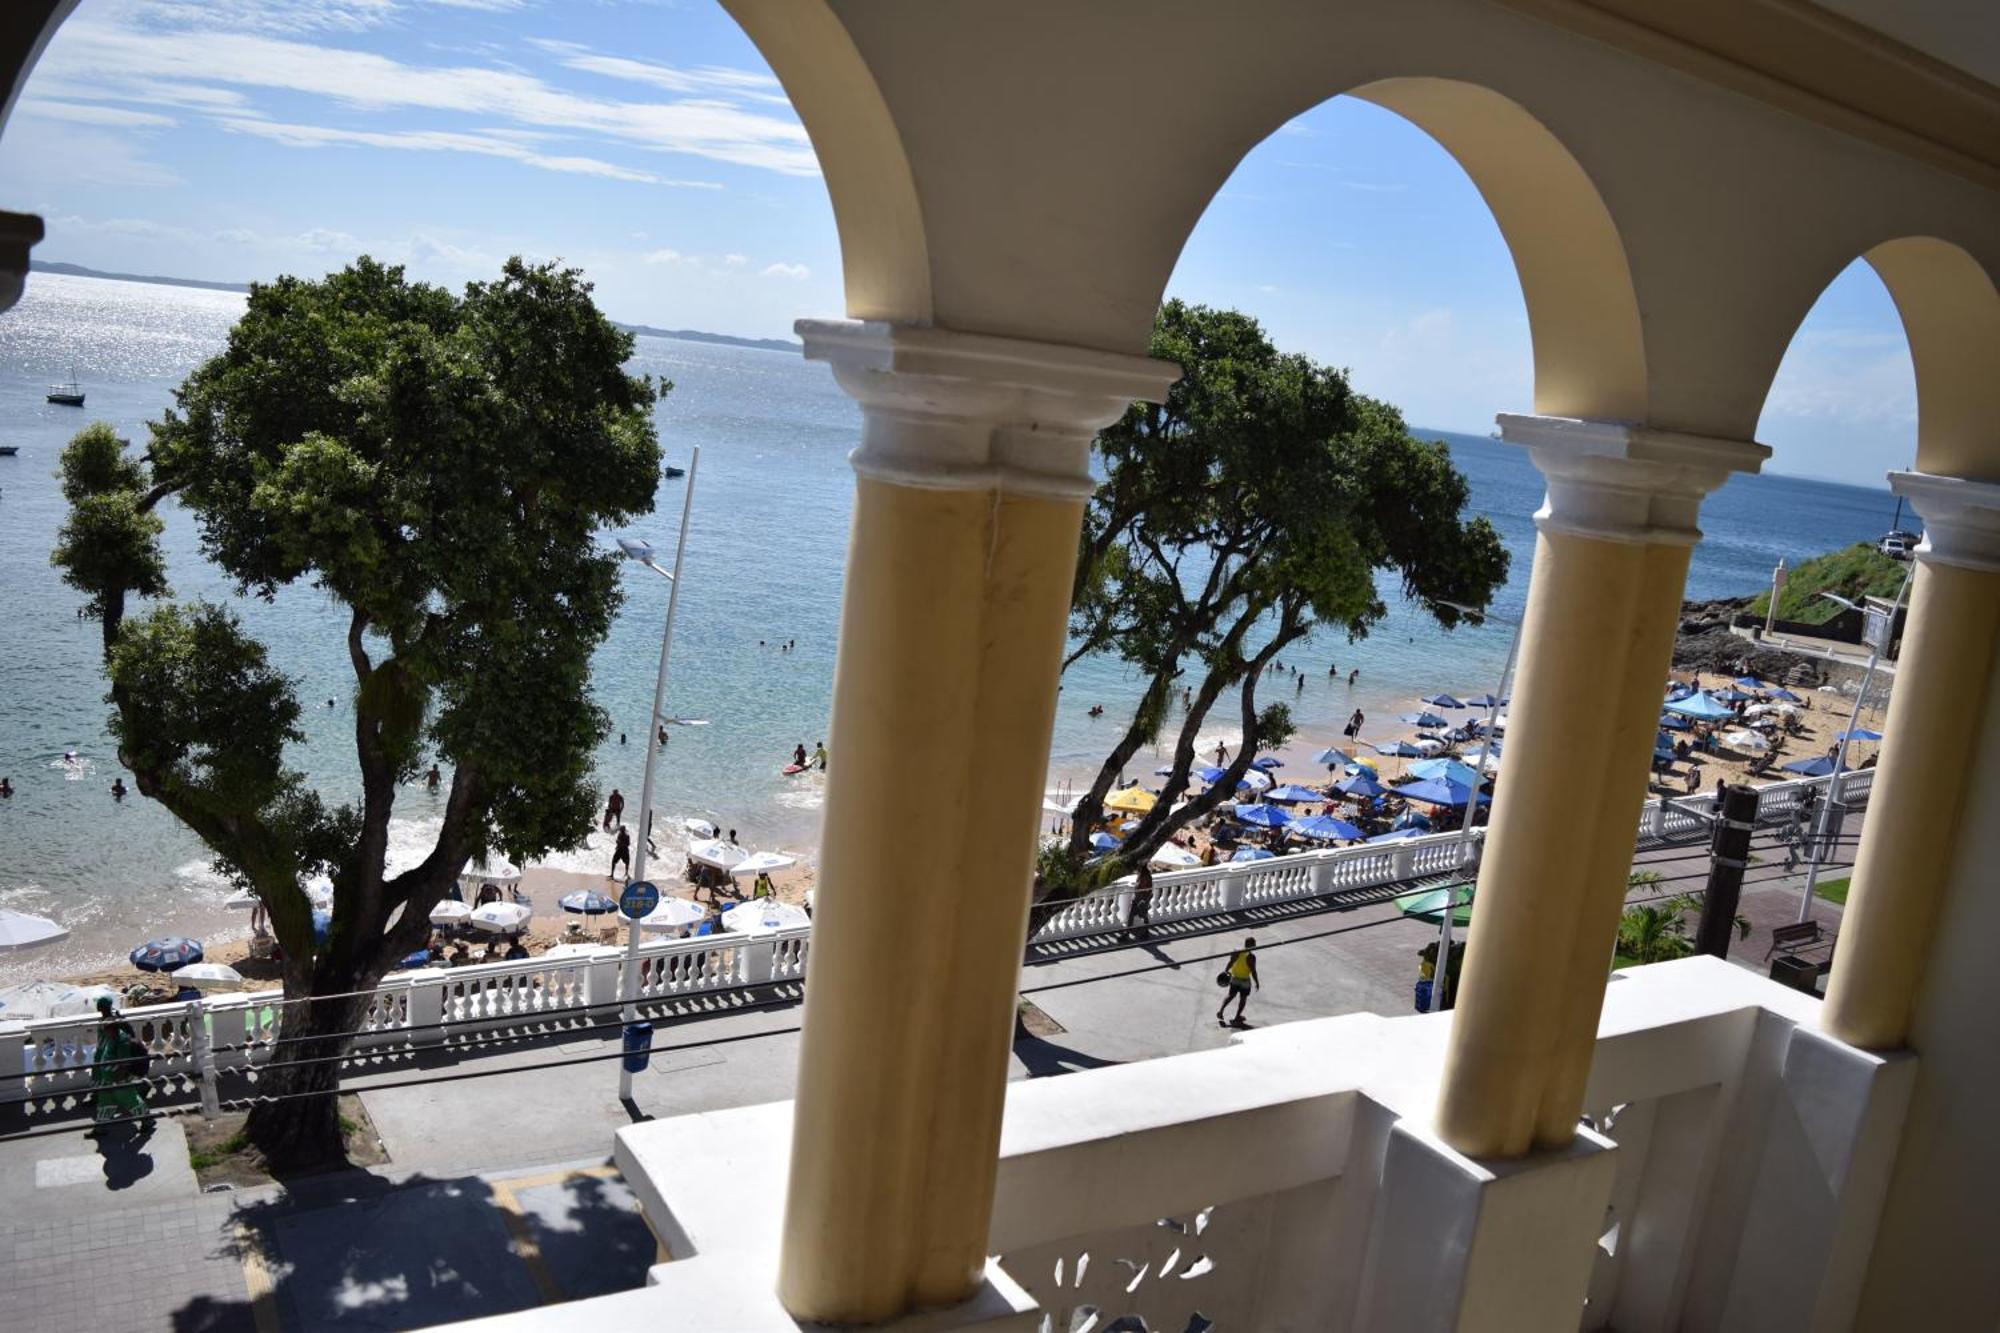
[1820, 472, 2000, 1051]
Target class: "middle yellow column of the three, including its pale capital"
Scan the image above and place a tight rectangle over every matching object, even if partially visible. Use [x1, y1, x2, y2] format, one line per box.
[1438, 416, 1768, 1157]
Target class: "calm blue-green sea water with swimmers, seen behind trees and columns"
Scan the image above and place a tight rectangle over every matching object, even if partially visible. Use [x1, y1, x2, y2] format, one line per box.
[0, 274, 1894, 981]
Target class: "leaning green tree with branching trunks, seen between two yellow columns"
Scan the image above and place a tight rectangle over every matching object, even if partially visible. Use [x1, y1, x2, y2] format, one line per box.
[1066, 300, 1508, 861]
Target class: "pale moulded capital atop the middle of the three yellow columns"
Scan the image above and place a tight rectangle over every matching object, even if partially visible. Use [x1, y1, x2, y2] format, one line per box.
[1496, 412, 1770, 546]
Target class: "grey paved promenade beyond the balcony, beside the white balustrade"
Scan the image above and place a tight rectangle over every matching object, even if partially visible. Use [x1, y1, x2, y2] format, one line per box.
[0, 804, 1860, 1333]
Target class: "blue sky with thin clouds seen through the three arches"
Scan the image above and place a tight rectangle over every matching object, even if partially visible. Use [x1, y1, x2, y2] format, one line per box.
[0, 0, 1916, 486]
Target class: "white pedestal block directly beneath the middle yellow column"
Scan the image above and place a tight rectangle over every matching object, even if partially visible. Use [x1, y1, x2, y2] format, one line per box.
[1354, 1121, 1618, 1333]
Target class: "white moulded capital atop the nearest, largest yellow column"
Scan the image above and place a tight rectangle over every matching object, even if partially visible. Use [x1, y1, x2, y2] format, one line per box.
[794, 320, 1180, 498]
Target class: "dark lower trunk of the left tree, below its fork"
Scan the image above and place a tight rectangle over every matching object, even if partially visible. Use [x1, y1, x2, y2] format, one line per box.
[244, 977, 368, 1171]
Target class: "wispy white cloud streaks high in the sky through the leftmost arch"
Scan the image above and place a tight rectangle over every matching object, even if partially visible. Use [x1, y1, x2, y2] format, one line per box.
[40, 10, 818, 184]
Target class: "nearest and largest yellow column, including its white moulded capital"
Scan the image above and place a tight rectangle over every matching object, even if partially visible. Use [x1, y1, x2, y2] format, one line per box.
[778, 322, 1176, 1323]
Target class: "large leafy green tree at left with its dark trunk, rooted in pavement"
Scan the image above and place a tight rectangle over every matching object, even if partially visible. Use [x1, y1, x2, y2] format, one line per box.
[54, 258, 668, 1163]
